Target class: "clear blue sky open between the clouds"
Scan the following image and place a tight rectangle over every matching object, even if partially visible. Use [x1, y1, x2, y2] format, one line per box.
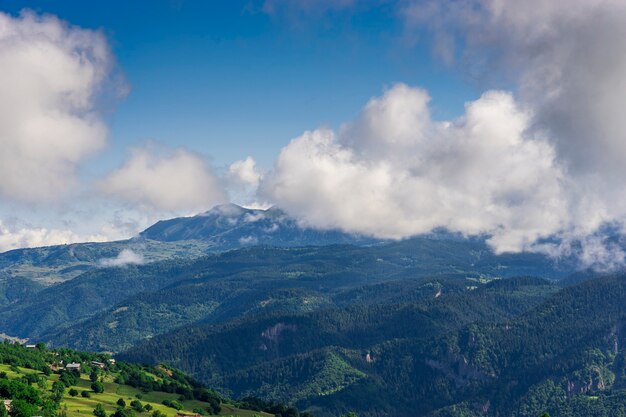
[1, 0, 478, 171]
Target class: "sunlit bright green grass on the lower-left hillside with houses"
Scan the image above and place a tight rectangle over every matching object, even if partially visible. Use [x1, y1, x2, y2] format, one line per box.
[0, 364, 272, 417]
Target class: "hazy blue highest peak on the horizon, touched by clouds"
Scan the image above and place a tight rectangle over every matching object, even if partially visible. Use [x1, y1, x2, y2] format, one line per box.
[140, 204, 380, 251]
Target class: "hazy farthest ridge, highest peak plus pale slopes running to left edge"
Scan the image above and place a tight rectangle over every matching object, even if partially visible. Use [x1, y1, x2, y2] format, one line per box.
[0, 204, 380, 288]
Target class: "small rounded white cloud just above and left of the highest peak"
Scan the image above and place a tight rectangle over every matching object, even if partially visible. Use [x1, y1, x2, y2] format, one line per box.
[99, 146, 227, 212]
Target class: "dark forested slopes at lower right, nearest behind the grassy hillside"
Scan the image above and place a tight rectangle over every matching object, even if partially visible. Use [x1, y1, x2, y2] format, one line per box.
[122, 276, 626, 417]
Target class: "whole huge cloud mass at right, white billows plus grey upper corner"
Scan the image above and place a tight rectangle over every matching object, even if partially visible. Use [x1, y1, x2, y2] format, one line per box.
[252, 0, 626, 269]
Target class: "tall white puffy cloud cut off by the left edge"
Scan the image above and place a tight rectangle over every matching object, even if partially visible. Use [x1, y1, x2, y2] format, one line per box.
[0, 12, 112, 202]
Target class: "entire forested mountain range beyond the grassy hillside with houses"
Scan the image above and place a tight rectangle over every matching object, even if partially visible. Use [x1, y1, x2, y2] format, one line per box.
[0, 205, 626, 417]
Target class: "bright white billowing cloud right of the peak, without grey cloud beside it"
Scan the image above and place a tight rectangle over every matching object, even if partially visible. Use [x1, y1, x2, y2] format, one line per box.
[262, 84, 568, 252]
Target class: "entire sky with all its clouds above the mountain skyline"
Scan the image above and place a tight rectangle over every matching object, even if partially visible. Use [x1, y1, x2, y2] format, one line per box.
[0, 0, 626, 265]
